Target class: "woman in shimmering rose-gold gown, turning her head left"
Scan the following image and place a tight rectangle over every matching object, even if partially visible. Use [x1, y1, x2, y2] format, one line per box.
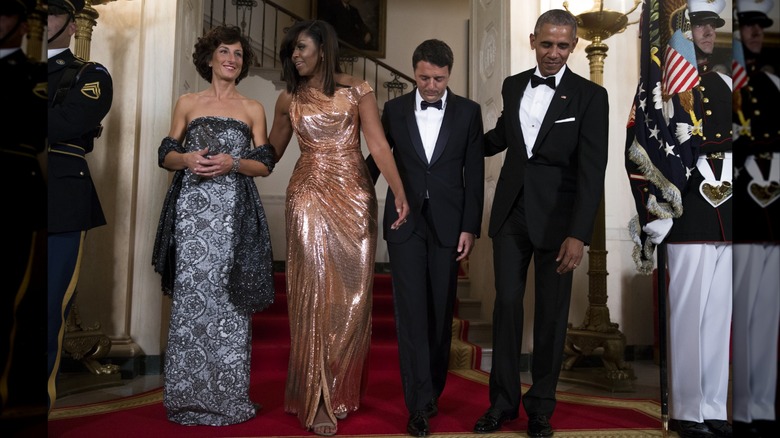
[269, 20, 409, 436]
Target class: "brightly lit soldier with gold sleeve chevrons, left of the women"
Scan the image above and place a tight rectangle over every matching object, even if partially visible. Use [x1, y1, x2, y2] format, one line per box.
[47, 0, 113, 408]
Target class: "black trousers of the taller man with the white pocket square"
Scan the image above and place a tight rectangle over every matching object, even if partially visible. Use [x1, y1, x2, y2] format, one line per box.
[490, 195, 572, 417]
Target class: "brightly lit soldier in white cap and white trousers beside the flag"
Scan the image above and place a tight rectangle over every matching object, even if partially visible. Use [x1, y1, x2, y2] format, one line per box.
[643, 0, 732, 438]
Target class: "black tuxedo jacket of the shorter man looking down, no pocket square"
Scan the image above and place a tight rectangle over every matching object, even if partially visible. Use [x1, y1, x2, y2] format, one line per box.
[368, 89, 485, 246]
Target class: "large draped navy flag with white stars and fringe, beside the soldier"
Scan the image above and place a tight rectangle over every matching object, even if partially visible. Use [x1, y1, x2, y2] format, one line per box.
[625, 0, 701, 272]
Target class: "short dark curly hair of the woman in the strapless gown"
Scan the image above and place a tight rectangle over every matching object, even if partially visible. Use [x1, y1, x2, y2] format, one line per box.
[192, 26, 255, 84]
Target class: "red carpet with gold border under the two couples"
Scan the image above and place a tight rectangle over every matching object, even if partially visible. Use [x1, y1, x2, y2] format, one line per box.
[48, 274, 661, 438]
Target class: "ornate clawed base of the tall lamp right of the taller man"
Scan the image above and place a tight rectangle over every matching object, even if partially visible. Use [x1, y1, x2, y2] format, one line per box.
[560, 327, 636, 392]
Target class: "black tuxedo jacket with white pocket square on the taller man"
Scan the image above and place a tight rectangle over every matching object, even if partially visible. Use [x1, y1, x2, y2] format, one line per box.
[485, 68, 609, 250]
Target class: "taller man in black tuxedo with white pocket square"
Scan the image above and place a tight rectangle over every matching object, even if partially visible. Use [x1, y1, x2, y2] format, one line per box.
[474, 9, 609, 437]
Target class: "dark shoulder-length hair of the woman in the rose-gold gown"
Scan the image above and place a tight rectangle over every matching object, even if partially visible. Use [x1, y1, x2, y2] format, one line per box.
[279, 20, 341, 96]
